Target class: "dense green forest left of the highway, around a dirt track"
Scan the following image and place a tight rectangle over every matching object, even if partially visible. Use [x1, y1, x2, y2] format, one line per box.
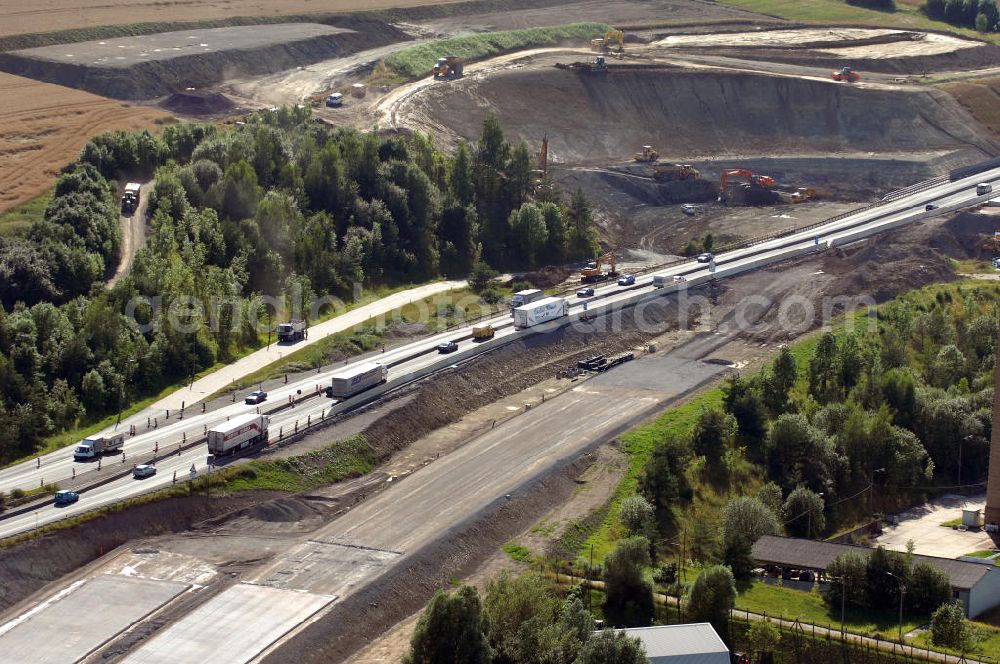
[0, 108, 598, 461]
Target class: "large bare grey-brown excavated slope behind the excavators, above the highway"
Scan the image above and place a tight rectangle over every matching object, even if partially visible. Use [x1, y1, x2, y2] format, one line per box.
[402, 66, 990, 165]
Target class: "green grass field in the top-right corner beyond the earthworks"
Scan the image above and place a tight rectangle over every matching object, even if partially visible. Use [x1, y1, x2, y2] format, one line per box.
[719, 0, 1000, 44]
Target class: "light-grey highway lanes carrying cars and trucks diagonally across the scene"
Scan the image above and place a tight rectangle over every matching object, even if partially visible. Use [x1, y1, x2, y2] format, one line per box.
[0, 169, 1000, 538]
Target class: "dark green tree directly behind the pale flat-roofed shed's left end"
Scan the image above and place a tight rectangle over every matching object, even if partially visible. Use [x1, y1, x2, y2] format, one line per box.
[603, 537, 653, 627]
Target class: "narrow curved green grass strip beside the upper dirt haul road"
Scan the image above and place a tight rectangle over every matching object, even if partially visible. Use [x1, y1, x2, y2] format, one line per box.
[385, 23, 611, 79]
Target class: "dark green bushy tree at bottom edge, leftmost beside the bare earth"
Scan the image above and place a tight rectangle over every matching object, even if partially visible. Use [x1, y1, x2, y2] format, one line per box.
[405, 586, 490, 664]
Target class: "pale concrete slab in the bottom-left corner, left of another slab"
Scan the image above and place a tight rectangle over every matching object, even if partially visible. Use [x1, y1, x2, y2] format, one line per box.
[0, 576, 186, 664]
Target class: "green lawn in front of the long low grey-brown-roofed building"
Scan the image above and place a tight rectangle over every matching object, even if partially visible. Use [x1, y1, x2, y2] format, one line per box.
[736, 581, 929, 639]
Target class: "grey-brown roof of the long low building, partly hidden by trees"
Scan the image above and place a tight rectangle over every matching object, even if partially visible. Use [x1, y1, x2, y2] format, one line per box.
[753, 535, 992, 590]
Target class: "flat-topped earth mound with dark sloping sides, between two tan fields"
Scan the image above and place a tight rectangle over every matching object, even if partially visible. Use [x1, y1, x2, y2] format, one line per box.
[0, 19, 409, 99]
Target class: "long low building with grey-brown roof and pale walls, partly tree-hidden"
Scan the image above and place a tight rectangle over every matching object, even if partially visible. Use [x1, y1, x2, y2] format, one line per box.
[752, 535, 1000, 618]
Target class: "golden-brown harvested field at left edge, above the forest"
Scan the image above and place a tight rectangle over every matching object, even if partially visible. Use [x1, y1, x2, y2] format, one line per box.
[0, 73, 170, 212]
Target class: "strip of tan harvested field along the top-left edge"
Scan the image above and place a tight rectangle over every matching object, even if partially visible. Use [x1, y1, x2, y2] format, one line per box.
[0, 0, 458, 36]
